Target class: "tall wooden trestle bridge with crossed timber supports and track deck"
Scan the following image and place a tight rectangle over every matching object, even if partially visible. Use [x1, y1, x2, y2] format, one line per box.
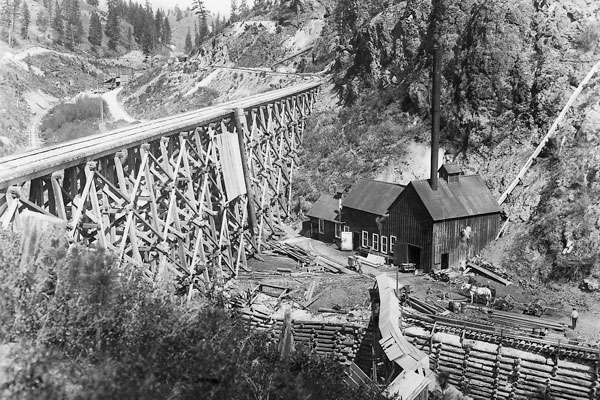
[0, 82, 320, 290]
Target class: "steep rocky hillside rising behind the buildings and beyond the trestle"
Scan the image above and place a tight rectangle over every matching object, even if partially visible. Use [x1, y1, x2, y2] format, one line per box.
[23, 0, 600, 290]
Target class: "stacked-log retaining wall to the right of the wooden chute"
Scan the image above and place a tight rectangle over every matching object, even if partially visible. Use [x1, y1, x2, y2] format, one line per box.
[404, 328, 599, 400]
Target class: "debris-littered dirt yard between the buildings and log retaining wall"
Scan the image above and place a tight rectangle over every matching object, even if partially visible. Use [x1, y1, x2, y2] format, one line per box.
[240, 227, 600, 345]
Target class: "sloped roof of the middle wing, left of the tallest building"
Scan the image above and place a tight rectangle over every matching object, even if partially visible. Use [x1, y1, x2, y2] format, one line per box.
[342, 179, 404, 215]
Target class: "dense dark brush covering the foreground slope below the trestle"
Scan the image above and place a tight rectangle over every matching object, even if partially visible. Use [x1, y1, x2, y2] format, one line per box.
[0, 234, 379, 399]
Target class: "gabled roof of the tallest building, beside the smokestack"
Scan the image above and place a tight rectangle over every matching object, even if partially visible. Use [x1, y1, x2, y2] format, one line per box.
[409, 175, 501, 221]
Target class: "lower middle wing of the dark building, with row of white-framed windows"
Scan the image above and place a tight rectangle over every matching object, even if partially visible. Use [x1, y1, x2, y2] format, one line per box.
[342, 179, 404, 261]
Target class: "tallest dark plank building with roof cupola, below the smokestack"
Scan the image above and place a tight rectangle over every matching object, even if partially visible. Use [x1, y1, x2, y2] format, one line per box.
[381, 164, 501, 272]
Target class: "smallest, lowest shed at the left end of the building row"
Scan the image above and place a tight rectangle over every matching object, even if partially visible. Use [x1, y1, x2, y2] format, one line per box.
[303, 194, 342, 243]
